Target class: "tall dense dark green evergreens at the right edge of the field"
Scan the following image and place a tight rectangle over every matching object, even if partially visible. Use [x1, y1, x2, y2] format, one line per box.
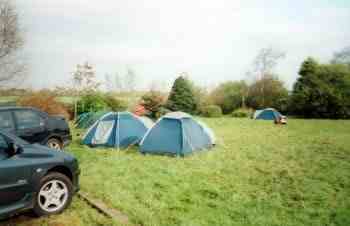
[291, 58, 350, 119]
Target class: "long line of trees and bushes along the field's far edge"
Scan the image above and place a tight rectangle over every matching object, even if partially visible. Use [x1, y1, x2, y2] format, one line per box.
[0, 54, 350, 119]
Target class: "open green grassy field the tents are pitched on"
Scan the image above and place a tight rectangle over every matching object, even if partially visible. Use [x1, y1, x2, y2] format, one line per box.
[0, 118, 350, 226]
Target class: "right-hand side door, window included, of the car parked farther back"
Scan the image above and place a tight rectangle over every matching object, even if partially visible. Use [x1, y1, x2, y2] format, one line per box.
[13, 109, 49, 143]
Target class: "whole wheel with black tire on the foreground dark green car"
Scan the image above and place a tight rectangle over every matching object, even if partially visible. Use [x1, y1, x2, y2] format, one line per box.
[33, 173, 73, 216]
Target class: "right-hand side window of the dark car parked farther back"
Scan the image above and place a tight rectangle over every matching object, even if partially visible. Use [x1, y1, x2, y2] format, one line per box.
[15, 110, 42, 129]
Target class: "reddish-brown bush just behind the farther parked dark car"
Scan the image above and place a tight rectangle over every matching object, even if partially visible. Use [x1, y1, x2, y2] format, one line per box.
[17, 91, 72, 120]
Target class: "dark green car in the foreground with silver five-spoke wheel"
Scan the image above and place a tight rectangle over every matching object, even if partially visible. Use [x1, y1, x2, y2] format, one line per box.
[0, 131, 80, 219]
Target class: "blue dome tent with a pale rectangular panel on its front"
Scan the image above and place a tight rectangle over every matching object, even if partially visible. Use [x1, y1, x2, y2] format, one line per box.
[82, 112, 151, 148]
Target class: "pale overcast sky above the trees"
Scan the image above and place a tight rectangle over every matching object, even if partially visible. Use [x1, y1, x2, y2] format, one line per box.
[15, 0, 350, 89]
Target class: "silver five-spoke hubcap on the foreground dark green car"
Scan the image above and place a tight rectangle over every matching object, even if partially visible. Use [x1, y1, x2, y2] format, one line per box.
[38, 180, 68, 212]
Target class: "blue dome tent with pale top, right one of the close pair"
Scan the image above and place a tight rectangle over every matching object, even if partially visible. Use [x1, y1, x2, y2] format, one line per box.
[140, 112, 215, 156]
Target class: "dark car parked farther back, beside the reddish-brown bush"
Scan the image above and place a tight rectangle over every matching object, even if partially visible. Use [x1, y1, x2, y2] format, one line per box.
[0, 107, 72, 149]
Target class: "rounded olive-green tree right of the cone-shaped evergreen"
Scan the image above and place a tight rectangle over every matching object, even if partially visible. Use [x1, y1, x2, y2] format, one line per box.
[210, 81, 248, 114]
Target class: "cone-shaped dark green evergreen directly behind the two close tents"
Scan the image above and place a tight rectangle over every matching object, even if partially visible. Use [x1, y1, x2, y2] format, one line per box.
[166, 76, 198, 114]
